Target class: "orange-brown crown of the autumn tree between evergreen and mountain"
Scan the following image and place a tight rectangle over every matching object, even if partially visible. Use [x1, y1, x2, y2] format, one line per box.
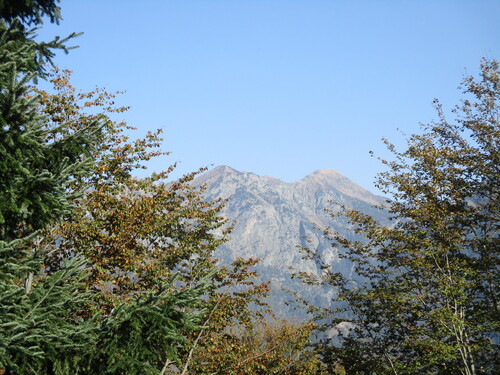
[39, 72, 227, 311]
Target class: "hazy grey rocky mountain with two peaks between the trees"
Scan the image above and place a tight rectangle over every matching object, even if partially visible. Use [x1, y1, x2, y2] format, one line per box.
[195, 166, 386, 316]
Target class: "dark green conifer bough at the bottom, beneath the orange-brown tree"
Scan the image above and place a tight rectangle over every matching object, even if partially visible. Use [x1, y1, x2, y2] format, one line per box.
[86, 280, 209, 375]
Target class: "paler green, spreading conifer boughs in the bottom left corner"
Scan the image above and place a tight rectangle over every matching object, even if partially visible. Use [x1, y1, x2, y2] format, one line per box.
[0, 251, 96, 375]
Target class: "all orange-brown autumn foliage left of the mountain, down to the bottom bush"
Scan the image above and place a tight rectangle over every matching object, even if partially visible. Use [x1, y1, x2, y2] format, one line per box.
[30, 71, 319, 374]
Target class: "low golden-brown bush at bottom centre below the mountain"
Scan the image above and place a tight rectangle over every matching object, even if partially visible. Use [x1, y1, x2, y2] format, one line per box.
[186, 317, 327, 375]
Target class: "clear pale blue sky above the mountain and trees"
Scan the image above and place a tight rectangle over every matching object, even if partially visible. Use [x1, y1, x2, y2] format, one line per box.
[40, 0, 500, 191]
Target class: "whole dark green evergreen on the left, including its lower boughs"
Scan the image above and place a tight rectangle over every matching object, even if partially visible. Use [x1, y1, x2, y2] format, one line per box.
[0, 1, 213, 375]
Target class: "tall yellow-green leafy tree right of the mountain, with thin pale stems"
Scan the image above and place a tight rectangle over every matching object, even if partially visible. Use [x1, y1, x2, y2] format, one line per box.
[302, 61, 500, 375]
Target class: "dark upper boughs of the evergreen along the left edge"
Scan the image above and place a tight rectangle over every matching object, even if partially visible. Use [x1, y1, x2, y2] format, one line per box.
[0, 21, 95, 241]
